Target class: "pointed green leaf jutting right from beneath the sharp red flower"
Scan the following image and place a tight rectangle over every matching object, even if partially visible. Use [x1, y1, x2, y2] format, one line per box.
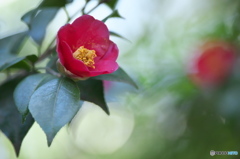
[93, 67, 138, 89]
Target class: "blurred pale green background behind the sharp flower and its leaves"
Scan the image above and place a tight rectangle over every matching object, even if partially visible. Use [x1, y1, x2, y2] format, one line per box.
[0, 0, 240, 159]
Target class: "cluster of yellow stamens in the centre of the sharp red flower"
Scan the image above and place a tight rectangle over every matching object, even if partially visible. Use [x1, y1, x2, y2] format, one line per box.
[73, 46, 97, 68]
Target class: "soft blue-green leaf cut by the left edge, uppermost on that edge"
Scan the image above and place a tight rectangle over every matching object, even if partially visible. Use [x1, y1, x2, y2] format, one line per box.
[0, 32, 27, 54]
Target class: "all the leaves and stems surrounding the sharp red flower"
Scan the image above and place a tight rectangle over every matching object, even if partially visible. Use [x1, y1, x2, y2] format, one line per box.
[0, 0, 137, 155]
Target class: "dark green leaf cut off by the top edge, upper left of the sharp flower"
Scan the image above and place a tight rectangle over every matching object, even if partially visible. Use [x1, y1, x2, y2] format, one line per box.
[39, 0, 73, 8]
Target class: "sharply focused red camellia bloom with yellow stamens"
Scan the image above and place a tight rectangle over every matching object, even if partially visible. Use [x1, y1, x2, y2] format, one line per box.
[57, 15, 118, 79]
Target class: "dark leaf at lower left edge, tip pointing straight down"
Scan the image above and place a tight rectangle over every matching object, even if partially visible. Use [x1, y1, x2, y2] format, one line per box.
[0, 79, 34, 155]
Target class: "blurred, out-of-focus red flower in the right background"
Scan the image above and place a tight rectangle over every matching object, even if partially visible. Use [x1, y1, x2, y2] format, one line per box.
[190, 41, 236, 87]
